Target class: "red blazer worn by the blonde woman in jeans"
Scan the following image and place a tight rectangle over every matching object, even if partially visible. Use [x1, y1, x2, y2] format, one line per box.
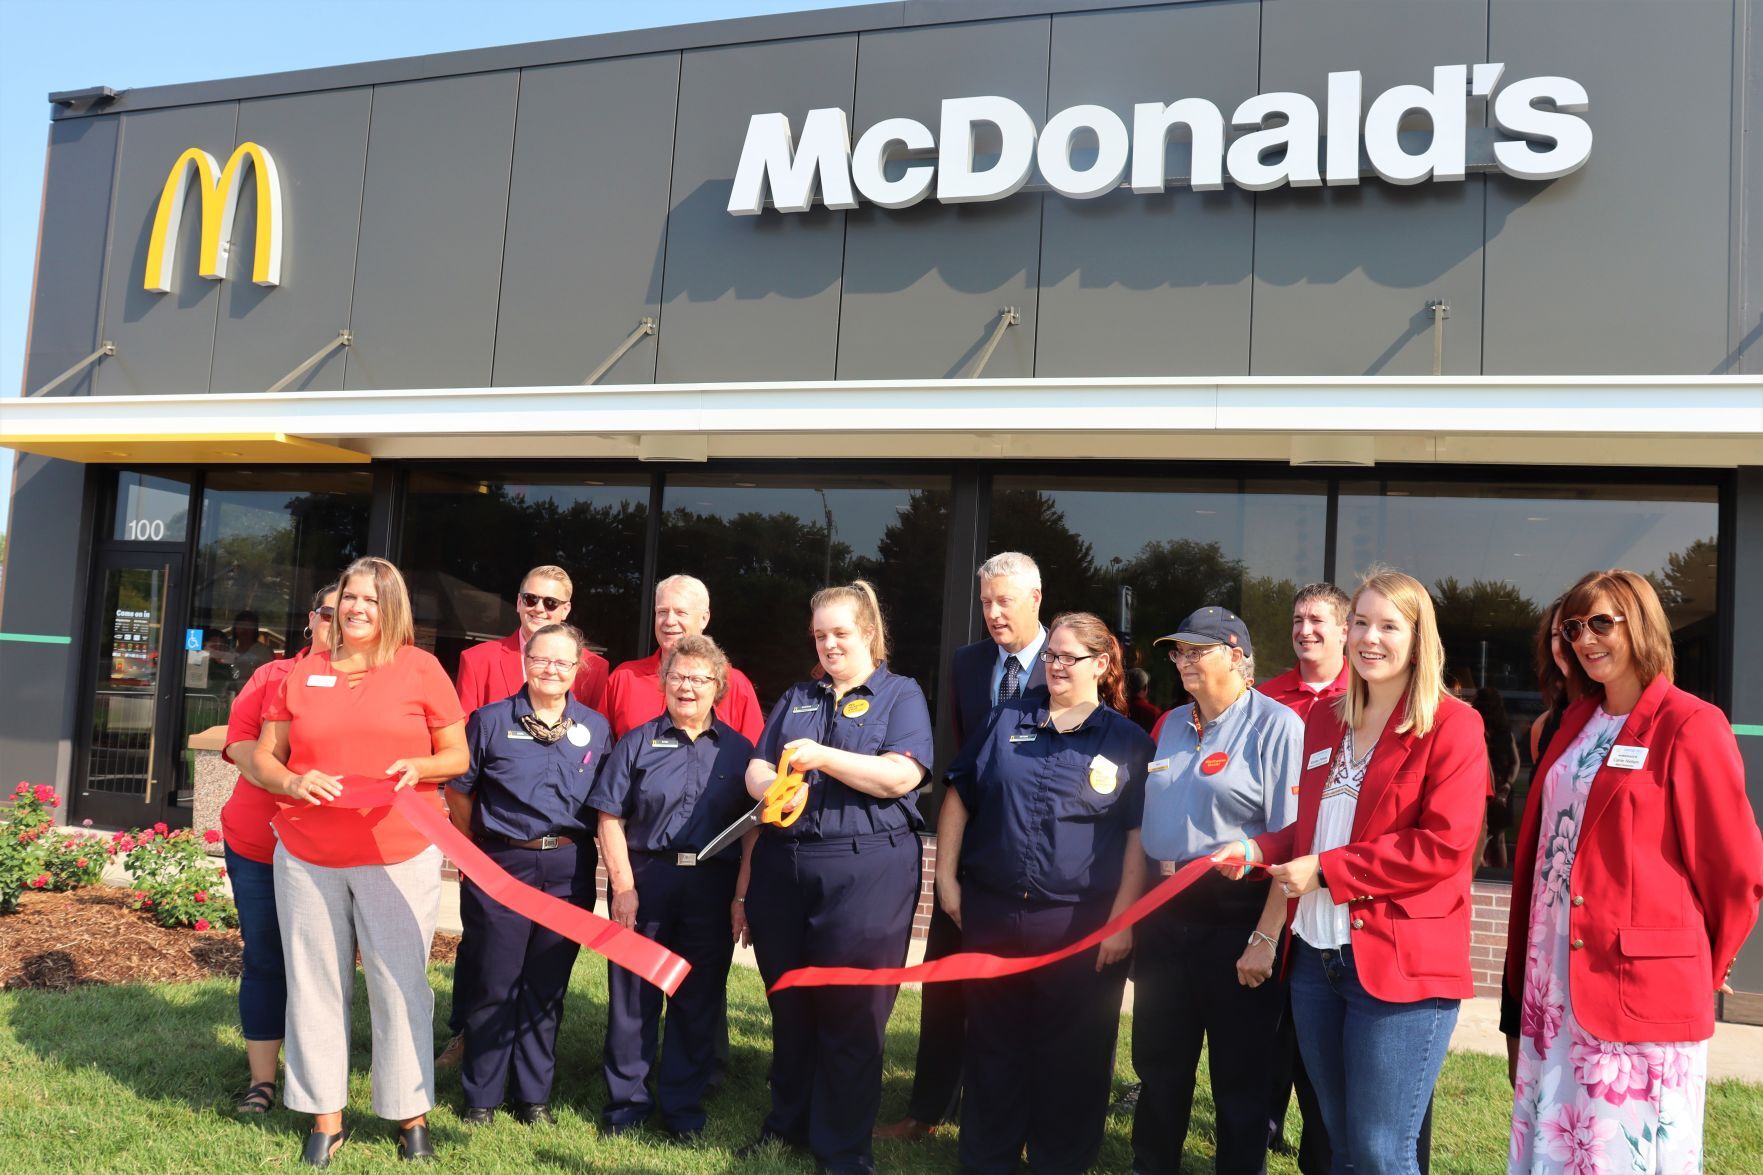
[1255, 697, 1488, 1004]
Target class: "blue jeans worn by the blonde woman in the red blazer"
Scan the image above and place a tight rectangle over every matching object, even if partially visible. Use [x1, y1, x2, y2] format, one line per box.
[1291, 939, 1460, 1175]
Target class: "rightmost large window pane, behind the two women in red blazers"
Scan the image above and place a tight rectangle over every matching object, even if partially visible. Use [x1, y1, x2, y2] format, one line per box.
[1336, 482, 1719, 873]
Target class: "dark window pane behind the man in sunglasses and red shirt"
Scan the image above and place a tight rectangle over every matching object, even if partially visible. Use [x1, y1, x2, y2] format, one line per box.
[400, 471, 649, 674]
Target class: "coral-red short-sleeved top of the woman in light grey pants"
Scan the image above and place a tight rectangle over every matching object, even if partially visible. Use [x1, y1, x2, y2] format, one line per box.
[263, 644, 465, 868]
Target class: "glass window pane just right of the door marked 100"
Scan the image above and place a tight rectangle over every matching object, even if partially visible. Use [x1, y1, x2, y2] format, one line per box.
[183, 469, 372, 800]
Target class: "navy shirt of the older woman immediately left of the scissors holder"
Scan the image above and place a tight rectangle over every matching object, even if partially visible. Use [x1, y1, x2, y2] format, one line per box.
[587, 713, 753, 863]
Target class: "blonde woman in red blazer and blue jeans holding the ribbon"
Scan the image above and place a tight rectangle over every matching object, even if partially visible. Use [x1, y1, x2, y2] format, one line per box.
[1215, 570, 1488, 1175]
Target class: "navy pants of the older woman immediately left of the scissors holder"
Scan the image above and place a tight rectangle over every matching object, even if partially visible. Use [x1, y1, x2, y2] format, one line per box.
[605, 852, 739, 1133]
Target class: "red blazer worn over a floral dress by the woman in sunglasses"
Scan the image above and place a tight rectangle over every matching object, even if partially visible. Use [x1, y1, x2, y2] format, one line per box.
[1506, 677, 1763, 1043]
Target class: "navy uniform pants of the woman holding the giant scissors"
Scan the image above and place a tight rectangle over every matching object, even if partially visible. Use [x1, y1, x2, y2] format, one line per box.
[748, 831, 919, 1171]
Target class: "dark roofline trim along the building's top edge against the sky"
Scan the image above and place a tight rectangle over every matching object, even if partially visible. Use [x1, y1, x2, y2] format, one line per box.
[48, 0, 1198, 120]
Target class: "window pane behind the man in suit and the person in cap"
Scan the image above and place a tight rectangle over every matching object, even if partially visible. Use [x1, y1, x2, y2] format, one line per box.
[986, 476, 1328, 709]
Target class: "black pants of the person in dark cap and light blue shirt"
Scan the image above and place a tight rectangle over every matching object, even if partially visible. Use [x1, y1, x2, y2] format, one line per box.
[1132, 873, 1285, 1175]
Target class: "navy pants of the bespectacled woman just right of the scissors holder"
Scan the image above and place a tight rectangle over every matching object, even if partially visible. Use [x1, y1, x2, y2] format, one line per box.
[961, 884, 1127, 1175]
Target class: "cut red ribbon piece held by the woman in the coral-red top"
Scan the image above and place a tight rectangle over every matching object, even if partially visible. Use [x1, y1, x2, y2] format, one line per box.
[330, 775, 691, 995]
